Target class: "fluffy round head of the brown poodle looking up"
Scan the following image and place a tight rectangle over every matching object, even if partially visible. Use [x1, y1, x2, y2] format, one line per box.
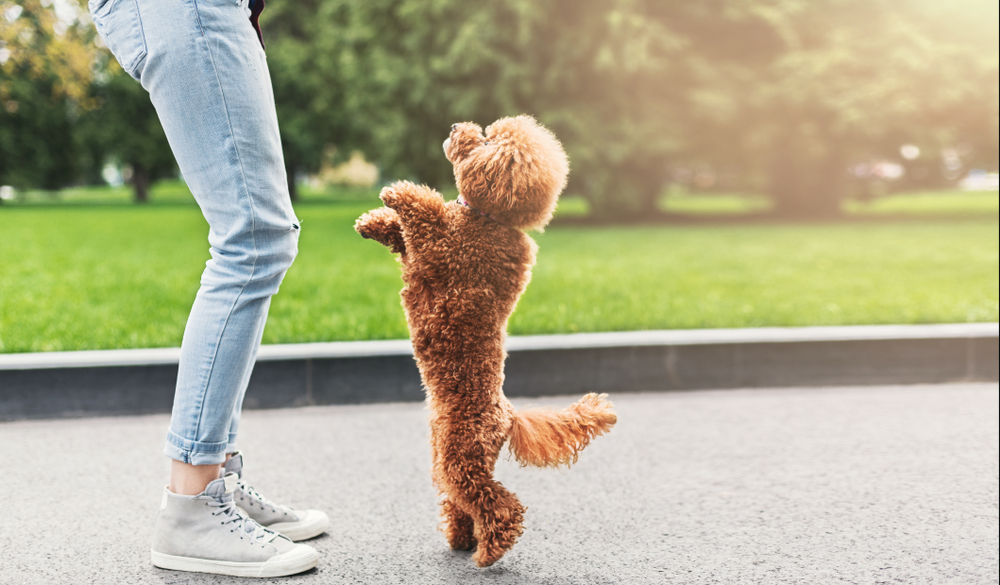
[444, 116, 569, 230]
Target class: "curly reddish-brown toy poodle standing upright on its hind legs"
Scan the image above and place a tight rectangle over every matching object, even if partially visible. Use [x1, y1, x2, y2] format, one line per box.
[355, 116, 617, 567]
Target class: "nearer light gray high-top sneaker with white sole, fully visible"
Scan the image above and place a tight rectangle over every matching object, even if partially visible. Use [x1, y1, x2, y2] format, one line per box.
[150, 473, 319, 577]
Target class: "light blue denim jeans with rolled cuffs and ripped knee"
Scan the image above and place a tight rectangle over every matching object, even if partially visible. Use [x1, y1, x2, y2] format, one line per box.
[90, 0, 299, 465]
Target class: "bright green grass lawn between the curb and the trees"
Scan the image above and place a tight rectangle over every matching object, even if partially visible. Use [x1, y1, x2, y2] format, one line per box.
[0, 195, 1000, 352]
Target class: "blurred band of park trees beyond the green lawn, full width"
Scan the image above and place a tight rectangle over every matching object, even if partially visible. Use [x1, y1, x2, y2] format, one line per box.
[0, 0, 1000, 213]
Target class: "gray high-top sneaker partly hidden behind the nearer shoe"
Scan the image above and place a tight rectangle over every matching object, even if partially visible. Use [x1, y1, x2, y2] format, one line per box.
[222, 451, 330, 541]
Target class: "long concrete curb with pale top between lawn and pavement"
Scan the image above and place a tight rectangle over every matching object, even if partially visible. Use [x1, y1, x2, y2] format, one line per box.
[0, 323, 1000, 420]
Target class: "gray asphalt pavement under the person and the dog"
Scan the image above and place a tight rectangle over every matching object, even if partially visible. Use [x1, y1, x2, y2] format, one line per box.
[0, 383, 1000, 585]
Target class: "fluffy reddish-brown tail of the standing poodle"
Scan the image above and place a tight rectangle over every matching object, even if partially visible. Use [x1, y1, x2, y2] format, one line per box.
[510, 393, 618, 467]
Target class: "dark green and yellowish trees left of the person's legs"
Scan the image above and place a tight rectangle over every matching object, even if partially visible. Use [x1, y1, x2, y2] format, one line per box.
[0, 0, 176, 201]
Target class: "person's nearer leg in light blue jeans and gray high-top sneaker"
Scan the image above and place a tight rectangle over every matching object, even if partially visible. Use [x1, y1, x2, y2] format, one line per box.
[90, 0, 319, 577]
